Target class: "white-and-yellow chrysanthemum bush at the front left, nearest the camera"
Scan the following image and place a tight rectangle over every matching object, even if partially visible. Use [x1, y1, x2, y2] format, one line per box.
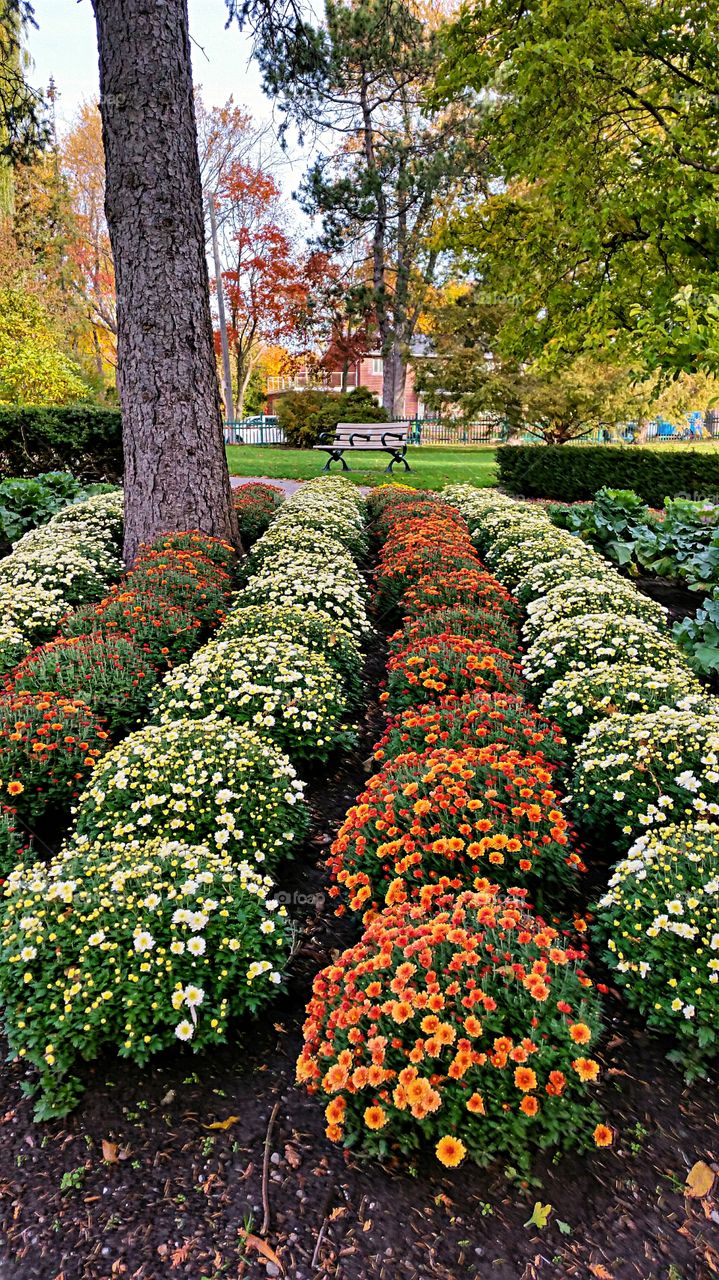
[0, 840, 290, 1119]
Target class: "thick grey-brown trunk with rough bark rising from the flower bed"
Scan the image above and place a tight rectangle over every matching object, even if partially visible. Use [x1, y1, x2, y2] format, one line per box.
[92, 0, 237, 561]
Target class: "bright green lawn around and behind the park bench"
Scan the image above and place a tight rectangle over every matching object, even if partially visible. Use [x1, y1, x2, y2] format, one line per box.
[228, 444, 496, 489]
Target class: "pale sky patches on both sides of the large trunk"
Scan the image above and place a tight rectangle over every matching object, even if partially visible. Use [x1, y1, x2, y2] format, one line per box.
[26, 0, 306, 196]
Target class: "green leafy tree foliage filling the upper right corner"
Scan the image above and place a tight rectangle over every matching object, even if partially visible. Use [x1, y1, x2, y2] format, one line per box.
[439, 0, 719, 375]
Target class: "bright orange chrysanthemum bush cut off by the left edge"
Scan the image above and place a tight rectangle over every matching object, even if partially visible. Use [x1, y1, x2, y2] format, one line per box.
[0, 692, 107, 826]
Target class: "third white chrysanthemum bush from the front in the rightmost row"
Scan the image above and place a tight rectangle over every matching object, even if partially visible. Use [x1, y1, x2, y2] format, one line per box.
[540, 662, 711, 740]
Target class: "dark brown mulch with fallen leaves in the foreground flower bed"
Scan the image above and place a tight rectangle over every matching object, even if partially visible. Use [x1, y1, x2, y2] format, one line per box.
[0, 622, 719, 1280]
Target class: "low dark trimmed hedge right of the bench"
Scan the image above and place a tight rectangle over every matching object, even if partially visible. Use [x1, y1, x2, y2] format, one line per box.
[498, 444, 719, 507]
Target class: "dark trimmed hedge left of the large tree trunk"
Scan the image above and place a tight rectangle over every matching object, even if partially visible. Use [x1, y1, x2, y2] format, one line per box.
[0, 404, 123, 481]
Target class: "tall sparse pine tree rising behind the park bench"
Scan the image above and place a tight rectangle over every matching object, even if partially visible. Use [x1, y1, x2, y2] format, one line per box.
[260, 0, 484, 416]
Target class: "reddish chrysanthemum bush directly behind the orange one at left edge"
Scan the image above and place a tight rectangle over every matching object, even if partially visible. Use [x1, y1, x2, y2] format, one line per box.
[5, 632, 159, 737]
